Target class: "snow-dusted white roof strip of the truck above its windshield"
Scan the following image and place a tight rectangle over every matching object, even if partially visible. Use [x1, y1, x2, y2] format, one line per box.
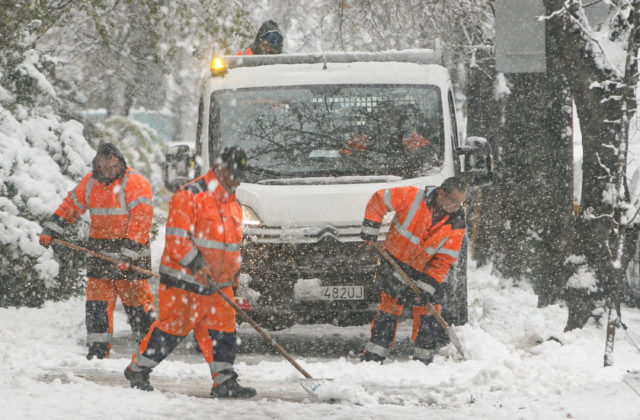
[207, 49, 450, 90]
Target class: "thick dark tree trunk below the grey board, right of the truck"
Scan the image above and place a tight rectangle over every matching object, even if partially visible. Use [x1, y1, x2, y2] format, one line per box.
[496, 73, 572, 306]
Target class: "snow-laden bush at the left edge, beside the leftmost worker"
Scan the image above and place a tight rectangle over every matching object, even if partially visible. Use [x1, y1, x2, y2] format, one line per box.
[0, 20, 95, 306]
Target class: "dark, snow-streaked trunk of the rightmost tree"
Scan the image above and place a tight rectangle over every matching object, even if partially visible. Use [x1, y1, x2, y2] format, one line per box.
[544, 0, 636, 330]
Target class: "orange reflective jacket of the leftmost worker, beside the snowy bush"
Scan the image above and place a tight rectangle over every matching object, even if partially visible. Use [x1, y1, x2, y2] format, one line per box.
[54, 167, 153, 245]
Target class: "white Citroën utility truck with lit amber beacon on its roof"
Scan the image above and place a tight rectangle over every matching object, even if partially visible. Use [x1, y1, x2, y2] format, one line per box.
[166, 49, 493, 328]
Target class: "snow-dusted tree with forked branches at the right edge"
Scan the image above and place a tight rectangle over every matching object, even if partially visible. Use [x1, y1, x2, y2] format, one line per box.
[544, 0, 640, 329]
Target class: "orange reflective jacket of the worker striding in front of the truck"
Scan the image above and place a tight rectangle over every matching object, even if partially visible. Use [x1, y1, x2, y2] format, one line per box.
[160, 169, 242, 294]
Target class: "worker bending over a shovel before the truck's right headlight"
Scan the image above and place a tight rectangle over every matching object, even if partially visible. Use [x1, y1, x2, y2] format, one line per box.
[361, 177, 466, 364]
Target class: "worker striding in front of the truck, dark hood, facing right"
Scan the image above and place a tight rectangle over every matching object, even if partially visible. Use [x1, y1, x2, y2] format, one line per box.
[124, 147, 256, 398]
